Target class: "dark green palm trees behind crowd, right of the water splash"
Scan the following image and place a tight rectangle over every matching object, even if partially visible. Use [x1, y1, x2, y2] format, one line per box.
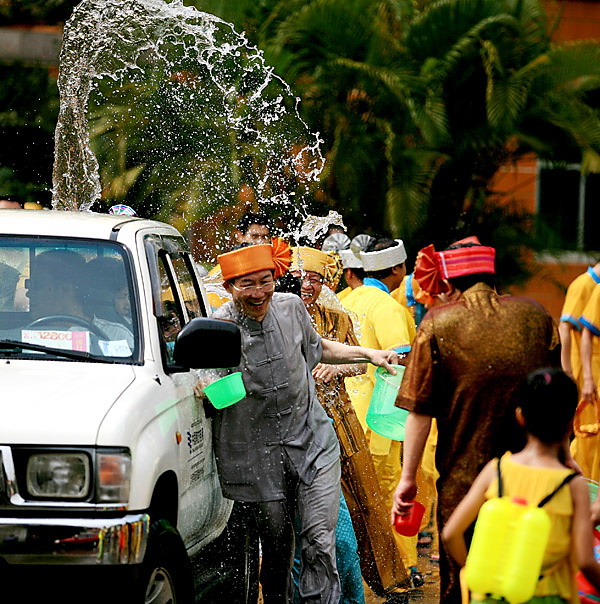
[191, 0, 600, 284]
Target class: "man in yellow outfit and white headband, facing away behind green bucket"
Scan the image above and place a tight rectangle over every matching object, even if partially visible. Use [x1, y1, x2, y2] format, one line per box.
[342, 238, 423, 587]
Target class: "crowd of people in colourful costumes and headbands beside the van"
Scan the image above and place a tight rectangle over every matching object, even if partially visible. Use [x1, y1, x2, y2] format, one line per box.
[197, 209, 600, 604]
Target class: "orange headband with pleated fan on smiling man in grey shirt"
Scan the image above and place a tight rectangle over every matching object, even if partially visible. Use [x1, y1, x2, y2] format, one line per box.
[217, 237, 292, 281]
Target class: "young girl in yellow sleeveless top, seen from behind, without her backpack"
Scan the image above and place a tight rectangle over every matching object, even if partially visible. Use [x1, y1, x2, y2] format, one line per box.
[442, 369, 600, 604]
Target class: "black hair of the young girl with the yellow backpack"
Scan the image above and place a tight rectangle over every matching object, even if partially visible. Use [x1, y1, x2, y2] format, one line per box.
[520, 367, 579, 445]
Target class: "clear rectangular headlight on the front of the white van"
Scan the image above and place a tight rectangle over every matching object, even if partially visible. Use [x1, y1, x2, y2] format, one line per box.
[27, 453, 90, 499]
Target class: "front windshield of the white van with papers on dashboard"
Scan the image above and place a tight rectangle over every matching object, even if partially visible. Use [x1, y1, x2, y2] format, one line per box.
[0, 235, 140, 363]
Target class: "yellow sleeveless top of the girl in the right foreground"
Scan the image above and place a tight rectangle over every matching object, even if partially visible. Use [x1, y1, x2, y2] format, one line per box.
[485, 453, 578, 604]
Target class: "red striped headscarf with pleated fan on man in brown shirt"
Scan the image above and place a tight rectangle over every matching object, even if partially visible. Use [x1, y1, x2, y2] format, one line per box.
[415, 237, 496, 295]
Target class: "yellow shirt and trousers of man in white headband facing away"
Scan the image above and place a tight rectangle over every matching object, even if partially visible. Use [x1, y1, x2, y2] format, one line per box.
[343, 285, 417, 567]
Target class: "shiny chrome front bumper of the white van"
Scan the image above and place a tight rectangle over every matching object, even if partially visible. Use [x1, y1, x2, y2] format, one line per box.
[0, 514, 150, 566]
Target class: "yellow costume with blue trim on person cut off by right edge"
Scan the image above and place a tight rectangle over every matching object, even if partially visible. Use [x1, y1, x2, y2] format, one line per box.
[571, 285, 600, 481]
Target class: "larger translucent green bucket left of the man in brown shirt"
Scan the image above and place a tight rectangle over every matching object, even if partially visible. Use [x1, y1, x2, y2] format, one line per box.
[367, 365, 408, 440]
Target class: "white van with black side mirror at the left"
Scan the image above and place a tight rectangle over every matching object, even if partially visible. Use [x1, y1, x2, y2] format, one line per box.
[0, 210, 251, 602]
